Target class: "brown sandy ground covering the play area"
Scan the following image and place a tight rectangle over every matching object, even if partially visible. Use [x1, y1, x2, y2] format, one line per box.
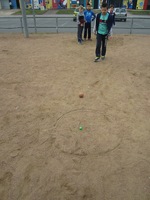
[0, 34, 150, 200]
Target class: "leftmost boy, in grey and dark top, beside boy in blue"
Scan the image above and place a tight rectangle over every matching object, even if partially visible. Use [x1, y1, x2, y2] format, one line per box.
[77, 5, 85, 44]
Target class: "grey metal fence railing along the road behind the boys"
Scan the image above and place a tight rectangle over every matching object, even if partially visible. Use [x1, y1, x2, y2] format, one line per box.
[0, 15, 150, 34]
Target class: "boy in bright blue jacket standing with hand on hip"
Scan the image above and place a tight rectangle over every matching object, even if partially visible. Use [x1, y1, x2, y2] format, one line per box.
[84, 3, 95, 41]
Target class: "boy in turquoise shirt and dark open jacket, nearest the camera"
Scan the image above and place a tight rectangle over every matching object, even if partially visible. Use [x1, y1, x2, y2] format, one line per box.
[95, 3, 113, 62]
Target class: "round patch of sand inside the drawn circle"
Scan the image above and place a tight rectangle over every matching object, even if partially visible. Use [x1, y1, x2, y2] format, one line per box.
[55, 110, 123, 156]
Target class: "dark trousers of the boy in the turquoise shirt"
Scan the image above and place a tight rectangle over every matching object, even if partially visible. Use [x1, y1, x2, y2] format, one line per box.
[95, 33, 108, 57]
